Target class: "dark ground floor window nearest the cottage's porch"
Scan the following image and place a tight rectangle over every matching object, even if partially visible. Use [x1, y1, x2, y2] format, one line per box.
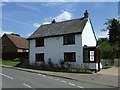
[64, 52, 76, 62]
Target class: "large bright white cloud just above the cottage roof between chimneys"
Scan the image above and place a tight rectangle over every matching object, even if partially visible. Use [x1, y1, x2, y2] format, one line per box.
[55, 11, 72, 22]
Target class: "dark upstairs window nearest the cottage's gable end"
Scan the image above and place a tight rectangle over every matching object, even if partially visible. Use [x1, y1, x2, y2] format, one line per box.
[63, 34, 75, 45]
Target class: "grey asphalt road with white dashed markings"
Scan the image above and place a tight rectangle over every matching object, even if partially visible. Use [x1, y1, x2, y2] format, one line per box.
[0, 67, 114, 90]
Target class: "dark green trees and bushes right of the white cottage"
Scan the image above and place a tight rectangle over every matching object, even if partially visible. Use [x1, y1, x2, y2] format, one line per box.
[98, 19, 120, 59]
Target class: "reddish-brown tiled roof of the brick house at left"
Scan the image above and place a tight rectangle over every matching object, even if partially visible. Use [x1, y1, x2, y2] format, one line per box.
[5, 34, 28, 49]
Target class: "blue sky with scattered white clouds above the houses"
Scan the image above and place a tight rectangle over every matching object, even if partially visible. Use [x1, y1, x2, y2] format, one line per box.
[0, 2, 118, 38]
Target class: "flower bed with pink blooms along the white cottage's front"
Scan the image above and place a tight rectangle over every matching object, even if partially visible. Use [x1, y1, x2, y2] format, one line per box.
[27, 59, 92, 74]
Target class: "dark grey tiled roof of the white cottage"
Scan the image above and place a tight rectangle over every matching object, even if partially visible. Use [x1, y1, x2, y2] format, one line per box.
[28, 18, 88, 39]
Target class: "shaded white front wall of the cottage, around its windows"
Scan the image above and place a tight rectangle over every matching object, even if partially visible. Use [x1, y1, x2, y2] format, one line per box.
[30, 34, 83, 64]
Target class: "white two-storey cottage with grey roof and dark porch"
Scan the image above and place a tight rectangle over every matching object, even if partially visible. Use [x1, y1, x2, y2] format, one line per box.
[28, 10, 102, 71]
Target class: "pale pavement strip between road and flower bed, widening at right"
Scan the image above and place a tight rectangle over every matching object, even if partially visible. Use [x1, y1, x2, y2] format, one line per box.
[2, 65, 120, 87]
